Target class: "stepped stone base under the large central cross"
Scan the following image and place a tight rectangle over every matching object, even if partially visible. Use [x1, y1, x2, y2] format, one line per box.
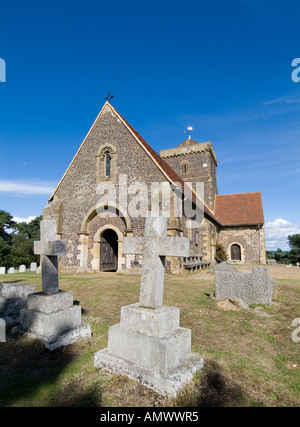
[94, 304, 203, 396]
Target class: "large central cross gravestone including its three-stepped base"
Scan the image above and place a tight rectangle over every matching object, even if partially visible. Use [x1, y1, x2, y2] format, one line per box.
[94, 217, 203, 396]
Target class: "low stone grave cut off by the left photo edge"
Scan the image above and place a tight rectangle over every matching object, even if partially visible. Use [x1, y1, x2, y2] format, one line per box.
[0, 283, 35, 325]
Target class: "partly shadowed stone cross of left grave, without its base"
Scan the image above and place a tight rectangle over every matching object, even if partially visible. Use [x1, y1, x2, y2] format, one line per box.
[34, 220, 66, 295]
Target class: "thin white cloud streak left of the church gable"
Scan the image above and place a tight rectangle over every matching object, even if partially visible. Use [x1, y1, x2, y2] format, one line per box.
[0, 180, 55, 196]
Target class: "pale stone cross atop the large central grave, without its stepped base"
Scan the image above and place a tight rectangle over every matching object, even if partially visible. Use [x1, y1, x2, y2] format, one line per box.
[123, 217, 189, 309]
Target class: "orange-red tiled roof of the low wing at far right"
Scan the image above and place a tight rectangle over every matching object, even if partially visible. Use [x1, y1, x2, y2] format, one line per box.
[215, 192, 265, 226]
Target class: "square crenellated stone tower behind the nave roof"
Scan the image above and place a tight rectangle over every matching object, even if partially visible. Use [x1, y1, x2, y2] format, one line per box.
[160, 137, 218, 212]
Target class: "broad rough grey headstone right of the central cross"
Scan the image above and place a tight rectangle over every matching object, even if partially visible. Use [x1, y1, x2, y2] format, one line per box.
[215, 266, 276, 305]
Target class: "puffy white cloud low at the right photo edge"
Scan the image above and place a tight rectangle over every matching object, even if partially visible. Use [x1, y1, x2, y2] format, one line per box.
[265, 218, 300, 251]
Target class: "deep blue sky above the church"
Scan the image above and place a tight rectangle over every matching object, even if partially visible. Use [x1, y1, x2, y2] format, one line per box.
[0, 0, 300, 249]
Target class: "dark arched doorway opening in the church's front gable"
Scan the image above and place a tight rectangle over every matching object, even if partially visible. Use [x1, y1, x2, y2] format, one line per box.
[100, 229, 118, 271]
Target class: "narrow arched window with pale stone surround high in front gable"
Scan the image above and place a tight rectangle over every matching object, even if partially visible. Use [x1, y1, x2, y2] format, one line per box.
[96, 143, 117, 184]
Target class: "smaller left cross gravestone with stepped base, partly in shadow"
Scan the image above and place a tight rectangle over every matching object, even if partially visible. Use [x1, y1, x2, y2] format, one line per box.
[17, 220, 91, 350]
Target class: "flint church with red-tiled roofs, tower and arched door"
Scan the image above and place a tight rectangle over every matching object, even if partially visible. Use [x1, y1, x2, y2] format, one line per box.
[43, 102, 266, 274]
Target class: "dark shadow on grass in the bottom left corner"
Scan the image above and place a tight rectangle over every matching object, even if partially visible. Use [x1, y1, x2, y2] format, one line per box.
[0, 333, 102, 407]
